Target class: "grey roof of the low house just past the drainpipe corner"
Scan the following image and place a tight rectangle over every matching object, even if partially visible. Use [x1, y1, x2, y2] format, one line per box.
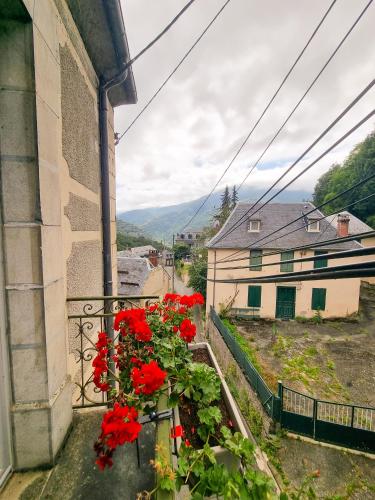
[117, 257, 152, 295]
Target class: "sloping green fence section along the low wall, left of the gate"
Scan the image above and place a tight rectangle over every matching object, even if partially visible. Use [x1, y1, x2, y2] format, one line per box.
[210, 307, 280, 421]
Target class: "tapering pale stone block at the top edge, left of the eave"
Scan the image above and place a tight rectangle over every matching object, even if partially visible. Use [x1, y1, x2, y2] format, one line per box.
[33, 0, 59, 60]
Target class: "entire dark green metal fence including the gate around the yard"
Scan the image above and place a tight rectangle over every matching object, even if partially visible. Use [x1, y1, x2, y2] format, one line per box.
[210, 308, 375, 453]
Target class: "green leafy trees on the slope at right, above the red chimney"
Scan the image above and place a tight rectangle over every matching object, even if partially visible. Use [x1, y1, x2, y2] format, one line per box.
[313, 131, 375, 225]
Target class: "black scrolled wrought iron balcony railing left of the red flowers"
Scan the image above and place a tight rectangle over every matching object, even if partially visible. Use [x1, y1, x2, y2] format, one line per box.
[67, 295, 159, 408]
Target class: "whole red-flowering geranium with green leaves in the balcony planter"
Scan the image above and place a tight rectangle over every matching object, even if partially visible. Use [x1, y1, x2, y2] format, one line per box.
[92, 294, 280, 499]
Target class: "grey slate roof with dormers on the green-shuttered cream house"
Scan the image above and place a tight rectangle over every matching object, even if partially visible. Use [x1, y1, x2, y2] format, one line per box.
[206, 202, 361, 250]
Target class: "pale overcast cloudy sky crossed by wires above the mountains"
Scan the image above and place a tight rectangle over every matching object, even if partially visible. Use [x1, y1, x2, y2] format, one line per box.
[116, 0, 375, 212]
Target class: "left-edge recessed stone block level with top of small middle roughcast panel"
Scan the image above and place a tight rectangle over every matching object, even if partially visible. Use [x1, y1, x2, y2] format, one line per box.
[0, 158, 40, 222]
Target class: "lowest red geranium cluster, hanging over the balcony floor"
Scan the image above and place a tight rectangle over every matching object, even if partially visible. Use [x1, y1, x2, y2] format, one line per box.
[95, 403, 142, 470]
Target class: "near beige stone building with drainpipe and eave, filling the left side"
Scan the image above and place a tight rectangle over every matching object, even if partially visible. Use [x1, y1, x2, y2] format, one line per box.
[0, 0, 136, 483]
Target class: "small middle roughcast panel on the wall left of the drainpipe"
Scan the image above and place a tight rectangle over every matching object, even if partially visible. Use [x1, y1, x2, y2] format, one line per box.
[64, 193, 101, 231]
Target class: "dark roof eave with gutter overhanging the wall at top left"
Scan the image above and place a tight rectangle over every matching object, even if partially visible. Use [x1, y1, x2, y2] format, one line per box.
[67, 0, 137, 106]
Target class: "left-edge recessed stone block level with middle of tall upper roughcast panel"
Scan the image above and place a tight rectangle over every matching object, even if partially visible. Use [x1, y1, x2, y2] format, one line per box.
[0, 89, 36, 158]
